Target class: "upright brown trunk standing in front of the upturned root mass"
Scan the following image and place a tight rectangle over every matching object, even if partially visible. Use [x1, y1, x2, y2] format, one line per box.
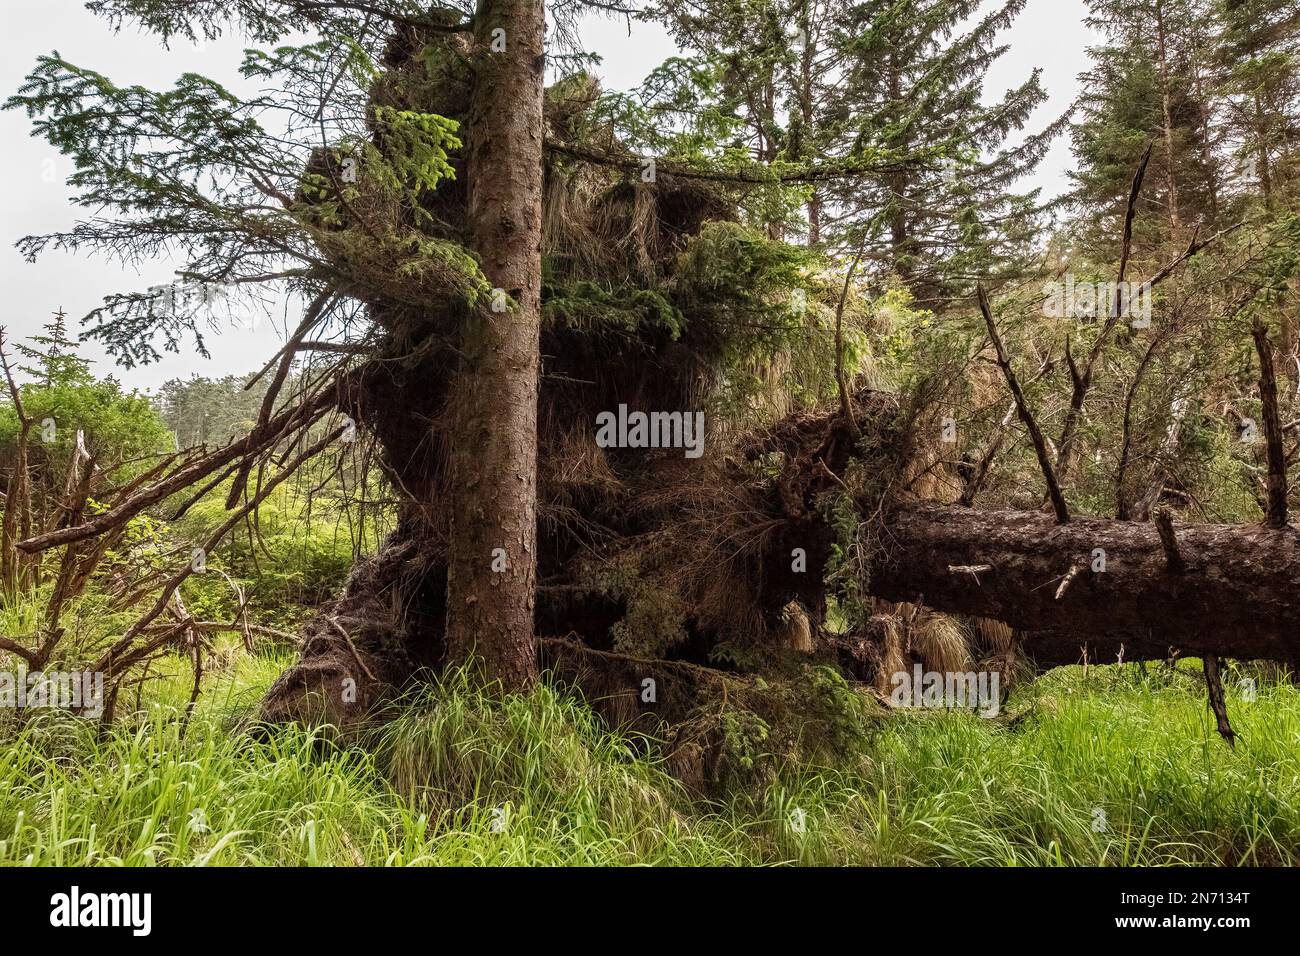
[446, 0, 545, 689]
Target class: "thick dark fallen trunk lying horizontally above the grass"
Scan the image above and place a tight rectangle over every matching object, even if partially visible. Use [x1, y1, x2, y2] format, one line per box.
[870, 502, 1300, 661]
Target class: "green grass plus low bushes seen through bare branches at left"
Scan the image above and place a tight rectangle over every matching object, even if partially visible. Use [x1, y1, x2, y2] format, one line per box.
[0, 323, 1279, 866]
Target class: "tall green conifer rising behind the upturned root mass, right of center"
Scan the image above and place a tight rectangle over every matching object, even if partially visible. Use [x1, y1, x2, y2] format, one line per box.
[663, 0, 1065, 304]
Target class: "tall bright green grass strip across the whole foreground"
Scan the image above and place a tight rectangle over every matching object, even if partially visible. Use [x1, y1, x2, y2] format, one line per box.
[0, 652, 1300, 866]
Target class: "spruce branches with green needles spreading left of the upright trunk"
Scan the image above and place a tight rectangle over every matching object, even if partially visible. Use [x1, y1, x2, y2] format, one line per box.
[4, 17, 473, 367]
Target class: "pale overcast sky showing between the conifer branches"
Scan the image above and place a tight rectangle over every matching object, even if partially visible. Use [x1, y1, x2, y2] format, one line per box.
[0, 0, 1093, 389]
